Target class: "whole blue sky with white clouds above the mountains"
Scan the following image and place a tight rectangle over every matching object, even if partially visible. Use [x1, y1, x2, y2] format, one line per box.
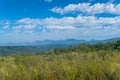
[0, 0, 120, 43]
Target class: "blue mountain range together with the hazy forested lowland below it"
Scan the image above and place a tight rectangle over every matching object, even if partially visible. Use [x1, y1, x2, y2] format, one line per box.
[0, 38, 120, 55]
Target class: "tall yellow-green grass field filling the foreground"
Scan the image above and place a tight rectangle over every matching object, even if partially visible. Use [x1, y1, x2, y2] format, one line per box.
[0, 51, 120, 80]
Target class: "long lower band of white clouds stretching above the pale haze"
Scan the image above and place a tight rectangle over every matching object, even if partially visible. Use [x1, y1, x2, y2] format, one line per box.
[12, 15, 120, 30]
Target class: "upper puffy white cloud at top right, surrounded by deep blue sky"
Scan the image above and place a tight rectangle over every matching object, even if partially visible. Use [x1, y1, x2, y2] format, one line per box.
[51, 3, 120, 15]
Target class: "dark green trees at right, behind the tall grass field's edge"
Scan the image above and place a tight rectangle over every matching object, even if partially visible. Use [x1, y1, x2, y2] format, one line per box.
[54, 40, 120, 54]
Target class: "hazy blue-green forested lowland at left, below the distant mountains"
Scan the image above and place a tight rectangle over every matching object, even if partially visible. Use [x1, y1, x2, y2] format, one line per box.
[0, 44, 68, 56]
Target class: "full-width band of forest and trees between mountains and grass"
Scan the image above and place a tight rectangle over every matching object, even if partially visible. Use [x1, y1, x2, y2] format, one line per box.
[0, 40, 120, 55]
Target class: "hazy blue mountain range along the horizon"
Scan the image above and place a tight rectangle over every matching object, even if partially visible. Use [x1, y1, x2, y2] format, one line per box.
[0, 37, 120, 46]
